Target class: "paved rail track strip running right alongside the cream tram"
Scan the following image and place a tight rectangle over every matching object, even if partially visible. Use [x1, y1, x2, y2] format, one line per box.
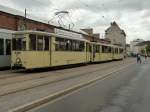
[0, 61, 132, 87]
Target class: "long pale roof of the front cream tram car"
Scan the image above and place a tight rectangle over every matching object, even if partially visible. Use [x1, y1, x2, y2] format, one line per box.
[13, 30, 89, 42]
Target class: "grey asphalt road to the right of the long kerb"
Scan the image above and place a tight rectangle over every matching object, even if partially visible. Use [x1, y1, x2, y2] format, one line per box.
[27, 59, 150, 112]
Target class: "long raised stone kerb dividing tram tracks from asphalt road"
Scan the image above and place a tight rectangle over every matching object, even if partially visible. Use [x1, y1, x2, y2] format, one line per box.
[12, 63, 135, 112]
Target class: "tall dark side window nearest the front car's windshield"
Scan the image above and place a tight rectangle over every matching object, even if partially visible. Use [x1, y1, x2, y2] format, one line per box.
[29, 34, 36, 50]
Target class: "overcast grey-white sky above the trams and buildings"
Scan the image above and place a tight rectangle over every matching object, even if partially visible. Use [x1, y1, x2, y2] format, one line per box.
[0, 0, 150, 43]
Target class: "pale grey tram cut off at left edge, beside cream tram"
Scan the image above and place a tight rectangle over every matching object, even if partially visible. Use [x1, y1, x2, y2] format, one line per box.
[0, 29, 12, 69]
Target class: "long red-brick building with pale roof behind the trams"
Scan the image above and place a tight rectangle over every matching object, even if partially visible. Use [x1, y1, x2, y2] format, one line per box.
[0, 5, 92, 36]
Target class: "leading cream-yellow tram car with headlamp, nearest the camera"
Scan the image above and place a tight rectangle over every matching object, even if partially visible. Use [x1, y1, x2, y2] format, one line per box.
[11, 31, 90, 69]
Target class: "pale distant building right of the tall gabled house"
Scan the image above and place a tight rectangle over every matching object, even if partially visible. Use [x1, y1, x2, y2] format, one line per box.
[130, 39, 144, 54]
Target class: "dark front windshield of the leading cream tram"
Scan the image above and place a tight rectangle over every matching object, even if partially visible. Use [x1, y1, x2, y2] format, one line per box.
[12, 35, 26, 51]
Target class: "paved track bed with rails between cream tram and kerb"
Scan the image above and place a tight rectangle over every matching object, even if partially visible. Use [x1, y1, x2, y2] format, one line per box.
[0, 59, 135, 112]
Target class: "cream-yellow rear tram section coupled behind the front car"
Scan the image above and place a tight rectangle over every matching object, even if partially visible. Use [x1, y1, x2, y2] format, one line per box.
[91, 42, 123, 62]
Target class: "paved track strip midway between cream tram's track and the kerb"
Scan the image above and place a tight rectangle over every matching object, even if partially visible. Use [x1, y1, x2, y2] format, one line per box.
[0, 58, 135, 96]
